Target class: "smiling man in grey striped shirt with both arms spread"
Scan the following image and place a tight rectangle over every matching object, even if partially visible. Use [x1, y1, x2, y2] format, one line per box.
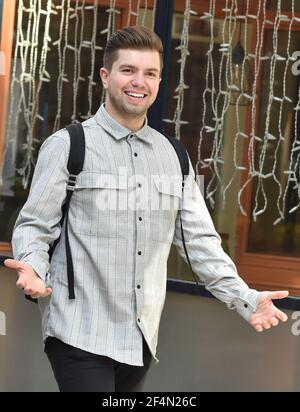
[5, 27, 288, 391]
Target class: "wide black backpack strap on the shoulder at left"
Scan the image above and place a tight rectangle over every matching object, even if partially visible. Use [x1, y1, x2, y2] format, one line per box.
[25, 123, 85, 303]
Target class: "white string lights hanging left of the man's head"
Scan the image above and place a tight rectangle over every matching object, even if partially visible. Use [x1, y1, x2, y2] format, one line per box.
[4, 0, 156, 188]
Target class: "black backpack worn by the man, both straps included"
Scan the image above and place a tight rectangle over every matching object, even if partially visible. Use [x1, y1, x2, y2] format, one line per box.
[25, 123, 198, 303]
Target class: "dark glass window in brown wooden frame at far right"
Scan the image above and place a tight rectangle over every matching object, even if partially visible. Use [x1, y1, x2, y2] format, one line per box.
[248, 30, 300, 257]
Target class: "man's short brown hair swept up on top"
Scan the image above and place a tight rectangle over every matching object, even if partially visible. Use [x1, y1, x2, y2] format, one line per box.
[103, 26, 164, 70]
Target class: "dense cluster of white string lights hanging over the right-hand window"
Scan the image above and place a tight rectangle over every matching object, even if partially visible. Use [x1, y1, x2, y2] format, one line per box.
[196, 0, 300, 225]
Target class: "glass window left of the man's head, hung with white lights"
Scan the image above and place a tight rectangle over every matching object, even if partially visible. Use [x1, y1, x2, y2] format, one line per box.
[0, 0, 155, 242]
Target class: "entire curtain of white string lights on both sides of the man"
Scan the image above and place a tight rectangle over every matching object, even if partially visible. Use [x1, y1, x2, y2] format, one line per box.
[5, 0, 300, 224]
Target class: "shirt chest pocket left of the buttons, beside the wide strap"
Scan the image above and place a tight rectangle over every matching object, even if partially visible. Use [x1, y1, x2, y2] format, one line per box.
[70, 171, 128, 237]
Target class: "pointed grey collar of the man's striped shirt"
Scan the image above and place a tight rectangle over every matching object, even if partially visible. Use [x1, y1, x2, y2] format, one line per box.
[95, 103, 153, 144]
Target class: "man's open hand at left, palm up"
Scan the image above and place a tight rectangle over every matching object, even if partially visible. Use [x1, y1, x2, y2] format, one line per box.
[4, 259, 52, 299]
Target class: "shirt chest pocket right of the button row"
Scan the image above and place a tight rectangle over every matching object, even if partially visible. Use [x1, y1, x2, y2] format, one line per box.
[150, 177, 182, 243]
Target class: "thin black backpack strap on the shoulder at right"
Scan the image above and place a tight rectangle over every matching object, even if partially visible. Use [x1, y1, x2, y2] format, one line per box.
[163, 133, 198, 285]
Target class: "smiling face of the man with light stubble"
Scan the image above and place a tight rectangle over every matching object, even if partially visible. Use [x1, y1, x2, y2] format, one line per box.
[100, 49, 160, 117]
